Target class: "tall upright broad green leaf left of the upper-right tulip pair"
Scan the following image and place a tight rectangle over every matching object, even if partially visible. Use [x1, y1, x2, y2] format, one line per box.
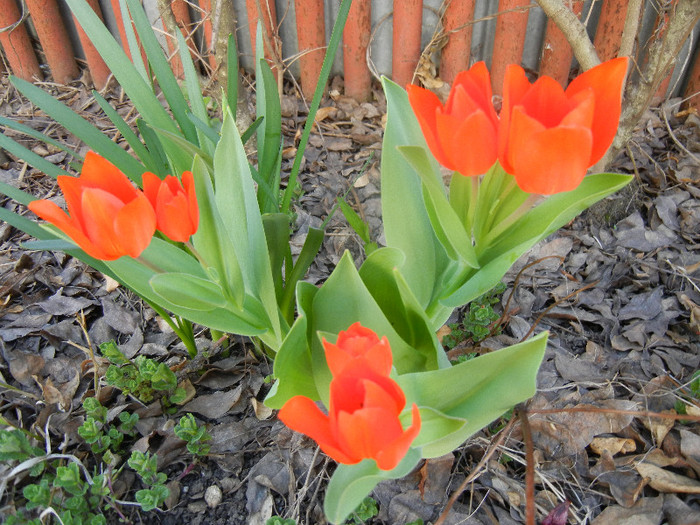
[381, 78, 447, 308]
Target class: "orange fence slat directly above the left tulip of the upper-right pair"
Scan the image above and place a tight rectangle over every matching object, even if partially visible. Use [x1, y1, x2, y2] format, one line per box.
[440, 0, 475, 84]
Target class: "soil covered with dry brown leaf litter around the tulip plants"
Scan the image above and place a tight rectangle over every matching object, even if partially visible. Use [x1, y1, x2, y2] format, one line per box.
[0, 74, 700, 525]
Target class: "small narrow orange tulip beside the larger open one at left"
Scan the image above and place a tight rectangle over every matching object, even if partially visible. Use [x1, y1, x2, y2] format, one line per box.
[143, 171, 199, 242]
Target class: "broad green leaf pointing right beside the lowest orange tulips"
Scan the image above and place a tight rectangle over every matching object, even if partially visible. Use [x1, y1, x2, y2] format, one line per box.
[397, 332, 547, 458]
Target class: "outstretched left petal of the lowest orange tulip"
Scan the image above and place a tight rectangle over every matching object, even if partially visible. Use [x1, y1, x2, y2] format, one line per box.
[278, 396, 362, 464]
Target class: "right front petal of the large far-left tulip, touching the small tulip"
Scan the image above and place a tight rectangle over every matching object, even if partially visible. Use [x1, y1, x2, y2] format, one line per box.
[113, 193, 156, 257]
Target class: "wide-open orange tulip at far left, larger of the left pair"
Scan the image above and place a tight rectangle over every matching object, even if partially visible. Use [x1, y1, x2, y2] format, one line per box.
[29, 152, 156, 261]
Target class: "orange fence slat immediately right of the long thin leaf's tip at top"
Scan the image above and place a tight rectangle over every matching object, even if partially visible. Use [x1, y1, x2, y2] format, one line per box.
[343, 0, 372, 102]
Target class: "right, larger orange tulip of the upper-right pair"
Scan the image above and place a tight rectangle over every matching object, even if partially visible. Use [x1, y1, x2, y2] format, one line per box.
[499, 57, 627, 195]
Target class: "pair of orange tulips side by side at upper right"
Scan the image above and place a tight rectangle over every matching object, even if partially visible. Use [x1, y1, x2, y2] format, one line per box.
[407, 57, 628, 195]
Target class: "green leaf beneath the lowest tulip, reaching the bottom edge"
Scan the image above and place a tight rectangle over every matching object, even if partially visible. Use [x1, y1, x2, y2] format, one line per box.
[323, 449, 420, 524]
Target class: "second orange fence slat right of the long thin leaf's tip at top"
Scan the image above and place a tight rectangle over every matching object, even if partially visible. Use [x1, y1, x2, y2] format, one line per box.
[391, 0, 423, 86]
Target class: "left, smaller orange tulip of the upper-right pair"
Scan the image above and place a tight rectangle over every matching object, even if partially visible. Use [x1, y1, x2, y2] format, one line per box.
[406, 62, 498, 176]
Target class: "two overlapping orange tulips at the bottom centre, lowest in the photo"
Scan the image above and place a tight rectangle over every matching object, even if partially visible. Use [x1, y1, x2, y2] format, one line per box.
[279, 323, 421, 470]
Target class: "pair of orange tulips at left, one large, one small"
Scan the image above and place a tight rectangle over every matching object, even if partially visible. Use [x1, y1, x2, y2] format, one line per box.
[29, 152, 199, 261]
